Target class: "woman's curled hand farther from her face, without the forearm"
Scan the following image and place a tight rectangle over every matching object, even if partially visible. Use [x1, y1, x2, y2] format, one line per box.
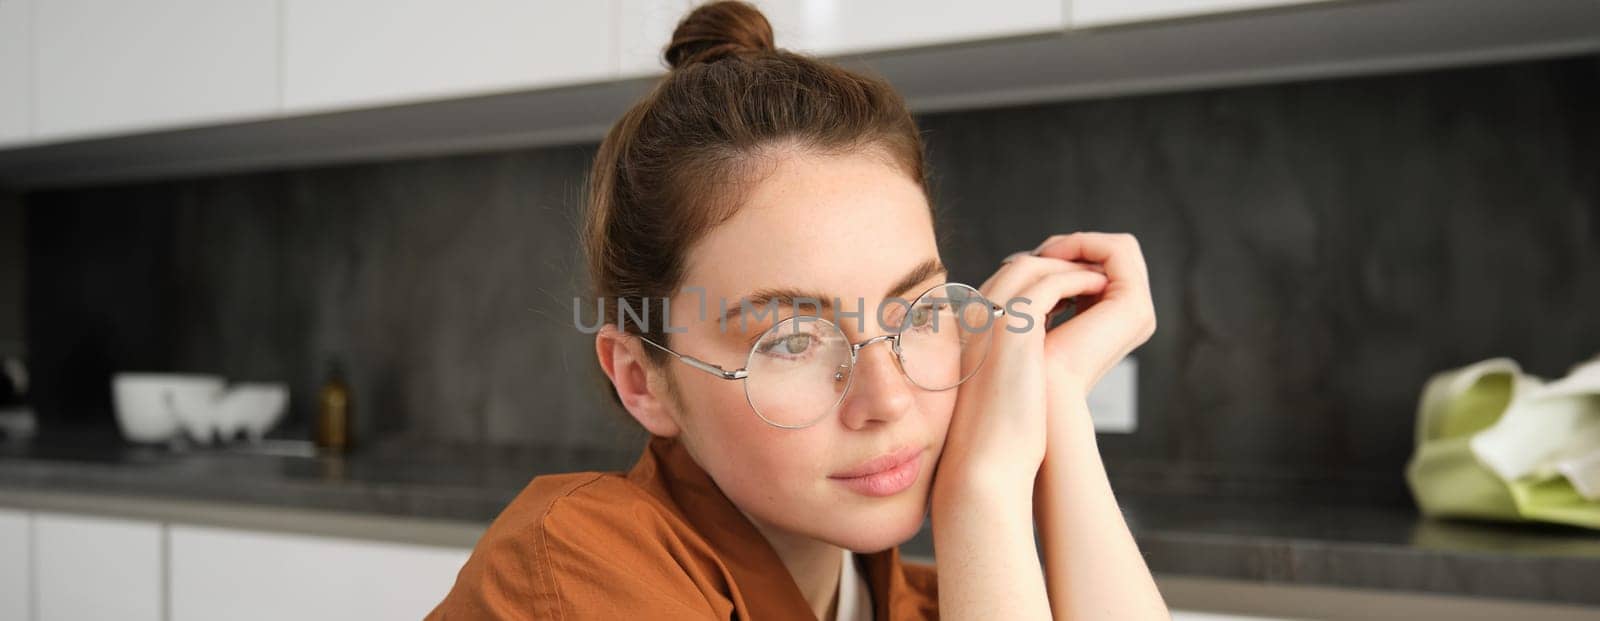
[1034, 232, 1155, 395]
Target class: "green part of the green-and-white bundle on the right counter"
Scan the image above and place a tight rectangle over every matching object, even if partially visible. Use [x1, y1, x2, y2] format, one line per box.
[1405, 360, 1600, 528]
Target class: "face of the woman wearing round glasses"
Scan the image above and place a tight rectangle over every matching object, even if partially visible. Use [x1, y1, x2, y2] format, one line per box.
[652, 149, 955, 552]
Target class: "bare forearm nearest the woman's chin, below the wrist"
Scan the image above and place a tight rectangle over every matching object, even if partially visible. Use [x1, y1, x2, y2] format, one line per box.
[933, 464, 1050, 621]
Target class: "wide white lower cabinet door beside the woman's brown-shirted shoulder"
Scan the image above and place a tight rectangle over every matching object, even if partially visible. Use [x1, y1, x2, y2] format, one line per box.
[170, 525, 470, 621]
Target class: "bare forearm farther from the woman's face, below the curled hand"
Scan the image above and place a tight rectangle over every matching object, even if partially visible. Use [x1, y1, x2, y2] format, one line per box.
[1036, 386, 1170, 619]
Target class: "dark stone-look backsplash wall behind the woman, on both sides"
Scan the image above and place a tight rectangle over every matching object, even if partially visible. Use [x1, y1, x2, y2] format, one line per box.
[15, 56, 1600, 499]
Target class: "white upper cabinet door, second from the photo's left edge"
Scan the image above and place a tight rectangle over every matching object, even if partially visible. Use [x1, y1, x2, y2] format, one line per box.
[30, 0, 278, 138]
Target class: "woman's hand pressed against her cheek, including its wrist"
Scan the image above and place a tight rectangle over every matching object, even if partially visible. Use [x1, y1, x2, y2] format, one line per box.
[938, 246, 1107, 495]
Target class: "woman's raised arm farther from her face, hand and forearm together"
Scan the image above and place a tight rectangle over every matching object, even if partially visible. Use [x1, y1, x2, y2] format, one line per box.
[1032, 232, 1170, 619]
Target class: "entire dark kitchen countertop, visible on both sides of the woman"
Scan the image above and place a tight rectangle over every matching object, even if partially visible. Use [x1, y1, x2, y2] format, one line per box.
[0, 443, 1600, 605]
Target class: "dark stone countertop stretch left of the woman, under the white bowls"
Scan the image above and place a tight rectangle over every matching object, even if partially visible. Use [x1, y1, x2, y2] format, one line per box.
[0, 442, 635, 525]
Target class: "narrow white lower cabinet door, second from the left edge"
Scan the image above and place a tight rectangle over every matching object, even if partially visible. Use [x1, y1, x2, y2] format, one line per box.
[34, 514, 165, 621]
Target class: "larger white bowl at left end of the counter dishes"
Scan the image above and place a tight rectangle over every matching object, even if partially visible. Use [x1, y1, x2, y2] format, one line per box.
[112, 373, 222, 443]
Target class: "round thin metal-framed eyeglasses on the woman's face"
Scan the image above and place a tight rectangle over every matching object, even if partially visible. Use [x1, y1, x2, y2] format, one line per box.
[640, 283, 1005, 429]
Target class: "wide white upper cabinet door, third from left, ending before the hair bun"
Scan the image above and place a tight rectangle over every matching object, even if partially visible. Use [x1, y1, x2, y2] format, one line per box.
[283, 0, 616, 112]
